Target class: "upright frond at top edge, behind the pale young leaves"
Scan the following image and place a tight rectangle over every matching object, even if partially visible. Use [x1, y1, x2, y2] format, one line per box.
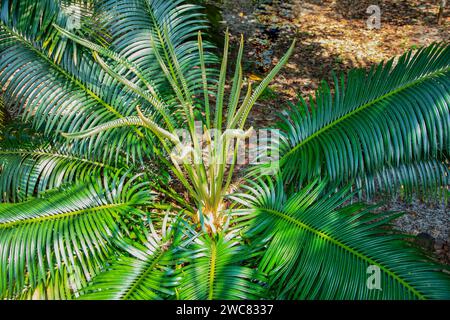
[100, 0, 217, 101]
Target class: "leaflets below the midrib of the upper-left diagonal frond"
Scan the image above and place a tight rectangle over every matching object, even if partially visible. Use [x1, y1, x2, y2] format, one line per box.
[0, 23, 114, 133]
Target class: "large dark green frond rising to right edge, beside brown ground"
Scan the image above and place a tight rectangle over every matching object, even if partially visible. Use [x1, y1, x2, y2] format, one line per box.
[280, 44, 450, 198]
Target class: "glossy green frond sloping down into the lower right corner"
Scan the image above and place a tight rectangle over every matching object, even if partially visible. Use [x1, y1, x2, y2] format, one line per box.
[238, 180, 450, 300]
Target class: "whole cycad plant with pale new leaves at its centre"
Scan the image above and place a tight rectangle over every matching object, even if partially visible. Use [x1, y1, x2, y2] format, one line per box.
[0, 0, 450, 299]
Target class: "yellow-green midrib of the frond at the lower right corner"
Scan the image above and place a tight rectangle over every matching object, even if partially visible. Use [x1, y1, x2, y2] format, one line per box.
[260, 208, 426, 300]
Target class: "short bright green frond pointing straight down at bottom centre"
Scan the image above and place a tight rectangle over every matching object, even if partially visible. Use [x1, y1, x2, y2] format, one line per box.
[179, 234, 264, 300]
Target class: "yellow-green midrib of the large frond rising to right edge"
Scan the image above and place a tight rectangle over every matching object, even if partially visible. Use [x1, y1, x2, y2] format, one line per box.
[280, 67, 450, 163]
